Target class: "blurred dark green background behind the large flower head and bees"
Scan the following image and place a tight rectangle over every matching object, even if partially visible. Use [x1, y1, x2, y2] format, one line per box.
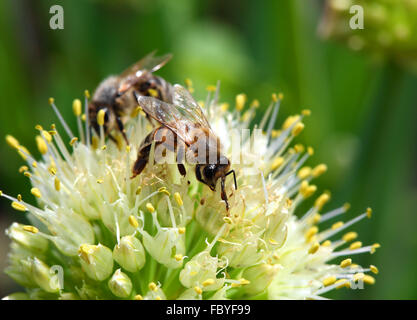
[0, 0, 417, 299]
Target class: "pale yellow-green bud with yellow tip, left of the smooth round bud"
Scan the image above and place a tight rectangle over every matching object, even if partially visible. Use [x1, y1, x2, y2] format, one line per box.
[78, 244, 113, 281]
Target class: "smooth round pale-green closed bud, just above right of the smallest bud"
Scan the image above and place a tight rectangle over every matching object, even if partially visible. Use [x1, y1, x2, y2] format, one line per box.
[113, 236, 145, 272]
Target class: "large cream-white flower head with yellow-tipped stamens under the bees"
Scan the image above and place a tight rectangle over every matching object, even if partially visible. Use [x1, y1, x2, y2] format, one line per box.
[1, 81, 379, 300]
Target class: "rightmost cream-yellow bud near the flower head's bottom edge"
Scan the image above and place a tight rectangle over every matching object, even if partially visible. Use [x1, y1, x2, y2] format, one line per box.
[242, 263, 279, 295]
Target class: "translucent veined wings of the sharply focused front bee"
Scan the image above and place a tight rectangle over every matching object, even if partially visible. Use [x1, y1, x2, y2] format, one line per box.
[135, 85, 215, 145]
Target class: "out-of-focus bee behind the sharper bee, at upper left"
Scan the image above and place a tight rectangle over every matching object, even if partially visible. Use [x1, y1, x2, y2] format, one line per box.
[88, 52, 172, 144]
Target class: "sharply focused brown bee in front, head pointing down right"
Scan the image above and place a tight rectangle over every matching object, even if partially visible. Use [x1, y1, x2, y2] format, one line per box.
[132, 84, 237, 211]
